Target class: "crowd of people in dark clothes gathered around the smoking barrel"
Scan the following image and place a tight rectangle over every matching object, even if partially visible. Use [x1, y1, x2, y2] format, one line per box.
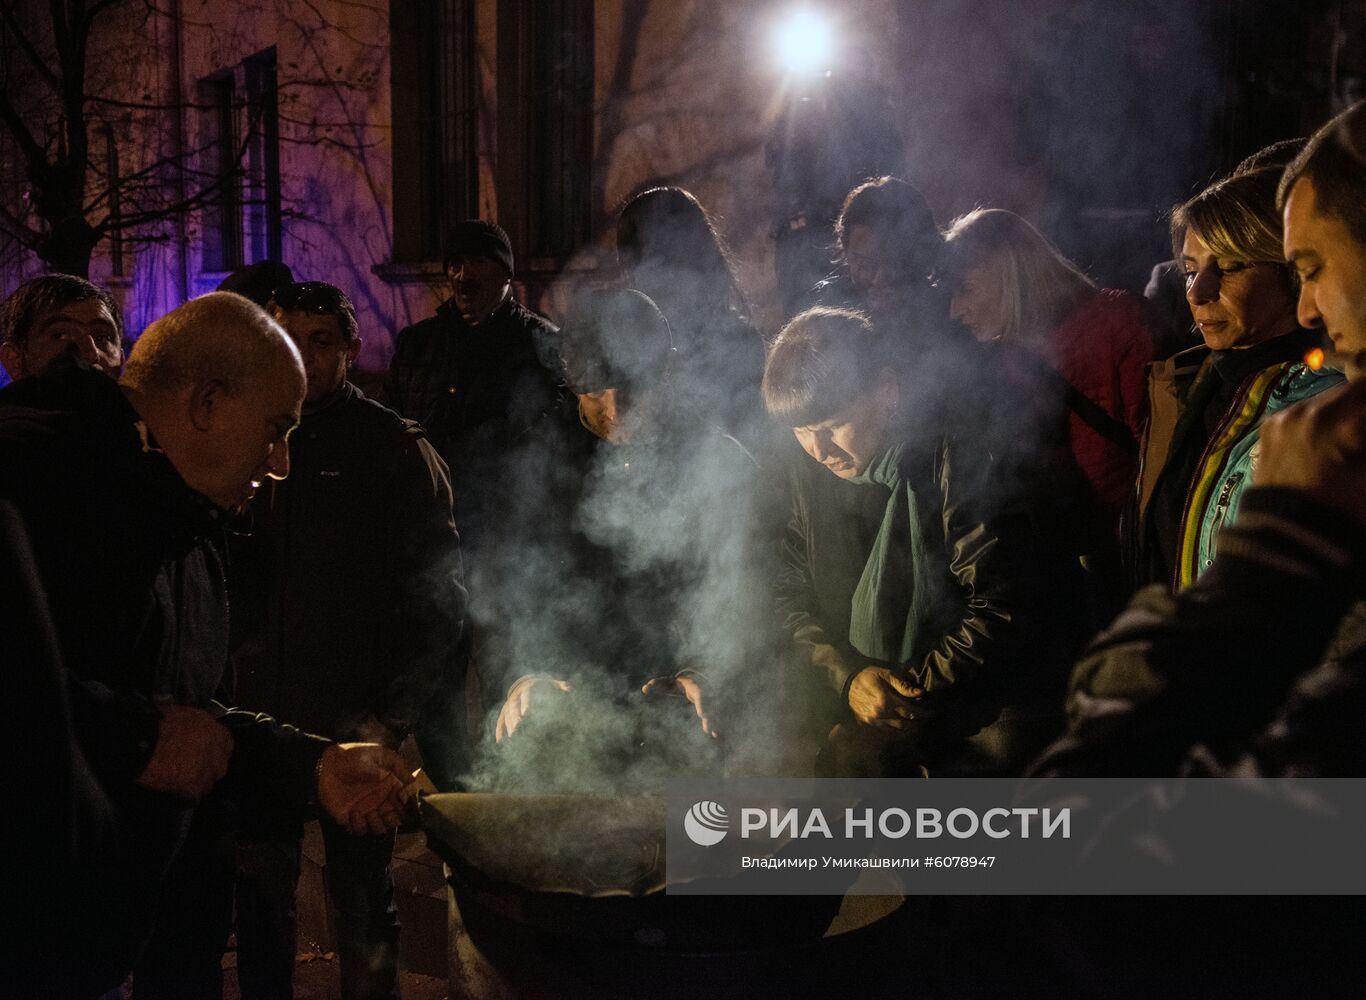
[8, 95, 1366, 1000]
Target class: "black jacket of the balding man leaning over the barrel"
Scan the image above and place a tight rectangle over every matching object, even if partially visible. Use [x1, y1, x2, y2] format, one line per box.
[0, 366, 325, 996]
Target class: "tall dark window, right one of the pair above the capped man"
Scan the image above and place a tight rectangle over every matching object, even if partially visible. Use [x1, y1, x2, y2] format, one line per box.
[499, 0, 593, 261]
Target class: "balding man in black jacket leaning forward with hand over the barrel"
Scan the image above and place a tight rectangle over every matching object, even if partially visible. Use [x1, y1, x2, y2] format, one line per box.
[0, 294, 403, 997]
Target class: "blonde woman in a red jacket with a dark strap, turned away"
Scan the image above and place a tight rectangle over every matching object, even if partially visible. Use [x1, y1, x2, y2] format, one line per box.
[945, 209, 1153, 538]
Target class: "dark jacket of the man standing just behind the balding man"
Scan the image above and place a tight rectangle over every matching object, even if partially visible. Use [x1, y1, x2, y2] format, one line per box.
[229, 383, 464, 739]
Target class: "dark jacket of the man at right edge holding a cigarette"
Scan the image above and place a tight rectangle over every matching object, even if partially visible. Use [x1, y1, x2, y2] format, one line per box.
[1034, 488, 1366, 777]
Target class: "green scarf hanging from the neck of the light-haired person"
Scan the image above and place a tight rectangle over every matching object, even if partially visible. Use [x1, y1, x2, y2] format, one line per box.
[850, 444, 928, 664]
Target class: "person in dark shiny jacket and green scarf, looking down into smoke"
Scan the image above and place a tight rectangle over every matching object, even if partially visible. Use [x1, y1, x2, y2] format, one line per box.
[764, 309, 1076, 776]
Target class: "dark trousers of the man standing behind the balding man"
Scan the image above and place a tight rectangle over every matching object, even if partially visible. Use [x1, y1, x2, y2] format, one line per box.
[238, 817, 399, 1000]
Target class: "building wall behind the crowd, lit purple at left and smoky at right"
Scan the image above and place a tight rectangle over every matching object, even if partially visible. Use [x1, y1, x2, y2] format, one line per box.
[8, 0, 1362, 370]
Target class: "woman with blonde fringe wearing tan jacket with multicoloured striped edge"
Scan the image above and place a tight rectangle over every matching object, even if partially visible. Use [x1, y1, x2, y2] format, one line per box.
[1124, 159, 1341, 590]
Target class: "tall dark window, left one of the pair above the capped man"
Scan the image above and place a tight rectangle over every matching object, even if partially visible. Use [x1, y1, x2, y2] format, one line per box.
[389, 0, 479, 261]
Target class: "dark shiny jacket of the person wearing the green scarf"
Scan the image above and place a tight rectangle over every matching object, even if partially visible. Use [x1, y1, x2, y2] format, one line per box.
[777, 428, 1078, 773]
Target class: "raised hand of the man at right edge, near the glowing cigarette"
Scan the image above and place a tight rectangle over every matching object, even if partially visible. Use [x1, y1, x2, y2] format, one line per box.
[1254, 381, 1366, 522]
